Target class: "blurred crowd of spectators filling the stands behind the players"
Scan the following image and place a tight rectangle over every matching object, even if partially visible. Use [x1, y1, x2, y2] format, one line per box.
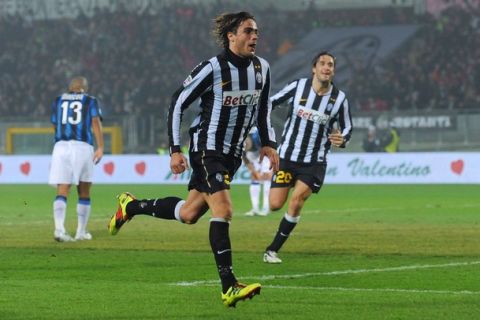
[0, 2, 480, 118]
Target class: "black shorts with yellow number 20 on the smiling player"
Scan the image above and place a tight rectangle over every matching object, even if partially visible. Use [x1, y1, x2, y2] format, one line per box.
[271, 159, 327, 193]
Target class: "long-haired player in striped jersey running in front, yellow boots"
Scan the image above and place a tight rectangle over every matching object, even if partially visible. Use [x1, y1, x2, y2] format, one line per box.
[109, 12, 279, 307]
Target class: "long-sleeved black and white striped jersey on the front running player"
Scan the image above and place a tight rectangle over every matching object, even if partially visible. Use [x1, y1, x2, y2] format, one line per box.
[168, 50, 276, 157]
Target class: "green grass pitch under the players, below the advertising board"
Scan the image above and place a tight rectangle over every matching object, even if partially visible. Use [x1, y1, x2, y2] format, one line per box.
[0, 185, 480, 320]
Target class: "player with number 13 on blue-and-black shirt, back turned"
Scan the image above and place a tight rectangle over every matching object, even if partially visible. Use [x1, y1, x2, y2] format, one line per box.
[49, 77, 103, 242]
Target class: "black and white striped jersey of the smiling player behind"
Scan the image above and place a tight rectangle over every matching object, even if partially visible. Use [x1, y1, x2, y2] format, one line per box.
[270, 78, 352, 163]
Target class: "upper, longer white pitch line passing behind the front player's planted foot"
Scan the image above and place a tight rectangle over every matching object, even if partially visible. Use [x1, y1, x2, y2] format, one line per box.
[170, 261, 480, 286]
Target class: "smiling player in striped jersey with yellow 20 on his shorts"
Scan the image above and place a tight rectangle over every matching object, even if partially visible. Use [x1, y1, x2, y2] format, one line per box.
[263, 51, 352, 263]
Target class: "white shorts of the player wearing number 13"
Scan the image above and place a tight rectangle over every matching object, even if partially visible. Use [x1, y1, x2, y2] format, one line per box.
[48, 140, 94, 186]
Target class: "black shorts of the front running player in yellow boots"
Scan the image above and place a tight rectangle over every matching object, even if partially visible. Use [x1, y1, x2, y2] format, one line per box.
[188, 151, 242, 194]
